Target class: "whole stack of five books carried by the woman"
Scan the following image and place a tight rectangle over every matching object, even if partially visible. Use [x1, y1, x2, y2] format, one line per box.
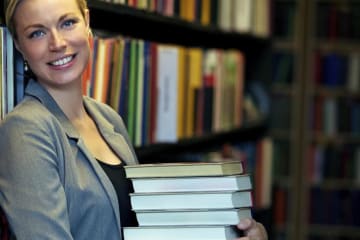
[124, 161, 253, 240]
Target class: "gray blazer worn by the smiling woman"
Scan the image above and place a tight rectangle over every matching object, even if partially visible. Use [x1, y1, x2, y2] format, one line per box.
[0, 81, 137, 240]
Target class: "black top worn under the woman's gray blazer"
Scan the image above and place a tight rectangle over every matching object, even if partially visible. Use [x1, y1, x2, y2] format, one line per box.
[98, 161, 138, 227]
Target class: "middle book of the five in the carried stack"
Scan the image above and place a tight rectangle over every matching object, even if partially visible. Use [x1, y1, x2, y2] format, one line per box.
[130, 190, 253, 210]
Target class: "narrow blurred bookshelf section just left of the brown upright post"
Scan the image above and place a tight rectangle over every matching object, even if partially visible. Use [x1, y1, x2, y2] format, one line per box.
[269, 0, 305, 240]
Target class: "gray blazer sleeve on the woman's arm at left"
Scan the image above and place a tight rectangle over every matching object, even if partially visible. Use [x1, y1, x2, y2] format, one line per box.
[0, 115, 73, 240]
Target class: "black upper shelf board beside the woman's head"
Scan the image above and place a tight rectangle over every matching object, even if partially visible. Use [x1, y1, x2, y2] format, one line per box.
[88, 0, 269, 54]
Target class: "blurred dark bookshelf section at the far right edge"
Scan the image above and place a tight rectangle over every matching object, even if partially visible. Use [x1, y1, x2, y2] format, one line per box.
[298, 0, 360, 240]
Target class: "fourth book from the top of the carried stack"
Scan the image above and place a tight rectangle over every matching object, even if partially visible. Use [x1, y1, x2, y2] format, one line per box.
[135, 208, 252, 226]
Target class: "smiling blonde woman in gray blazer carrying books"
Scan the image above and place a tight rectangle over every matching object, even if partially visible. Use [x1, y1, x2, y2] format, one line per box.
[0, 0, 267, 240]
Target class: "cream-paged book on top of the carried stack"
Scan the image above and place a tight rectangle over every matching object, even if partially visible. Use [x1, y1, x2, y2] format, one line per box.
[125, 160, 244, 178]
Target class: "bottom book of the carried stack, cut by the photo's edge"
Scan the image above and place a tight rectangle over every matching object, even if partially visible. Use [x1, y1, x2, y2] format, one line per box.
[124, 225, 242, 240]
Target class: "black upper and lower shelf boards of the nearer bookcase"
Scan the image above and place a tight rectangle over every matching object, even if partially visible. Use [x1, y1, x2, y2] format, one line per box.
[83, 0, 270, 158]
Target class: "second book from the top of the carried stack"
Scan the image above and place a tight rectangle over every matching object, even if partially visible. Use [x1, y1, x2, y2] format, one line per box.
[132, 174, 252, 193]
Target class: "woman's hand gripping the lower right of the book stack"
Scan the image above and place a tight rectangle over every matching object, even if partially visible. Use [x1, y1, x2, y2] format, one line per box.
[237, 218, 268, 240]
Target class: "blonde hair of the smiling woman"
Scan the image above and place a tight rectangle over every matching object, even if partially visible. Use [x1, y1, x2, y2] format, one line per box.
[4, 0, 87, 39]
